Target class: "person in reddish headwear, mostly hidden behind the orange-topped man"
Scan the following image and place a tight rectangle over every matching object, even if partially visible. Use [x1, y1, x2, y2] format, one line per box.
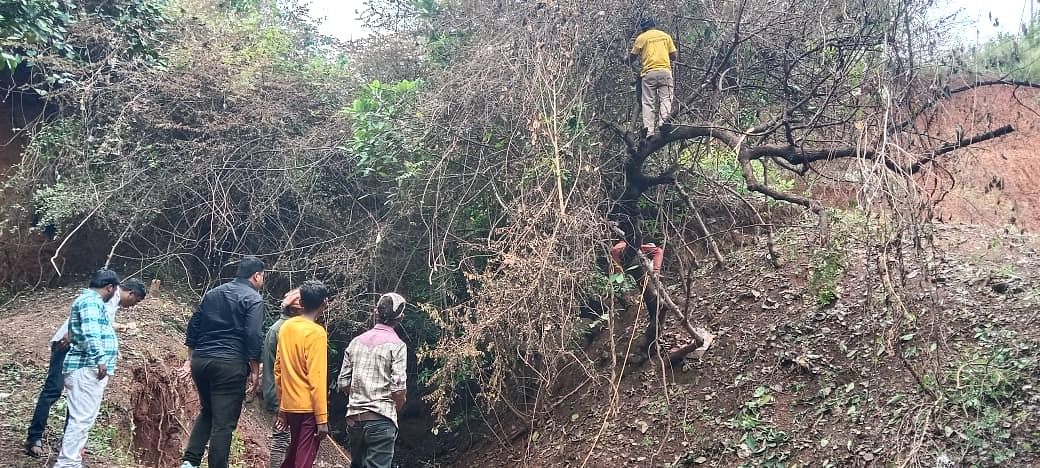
[260, 288, 304, 468]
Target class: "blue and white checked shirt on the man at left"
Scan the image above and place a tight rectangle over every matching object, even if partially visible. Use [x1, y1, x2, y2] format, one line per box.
[61, 289, 120, 374]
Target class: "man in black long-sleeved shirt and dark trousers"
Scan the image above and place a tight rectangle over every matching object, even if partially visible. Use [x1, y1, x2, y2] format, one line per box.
[181, 257, 265, 468]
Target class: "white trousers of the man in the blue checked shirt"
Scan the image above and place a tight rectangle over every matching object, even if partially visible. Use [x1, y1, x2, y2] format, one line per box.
[54, 367, 108, 468]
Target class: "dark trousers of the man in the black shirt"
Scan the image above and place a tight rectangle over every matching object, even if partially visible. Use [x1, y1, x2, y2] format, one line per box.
[181, 358, 250, 468]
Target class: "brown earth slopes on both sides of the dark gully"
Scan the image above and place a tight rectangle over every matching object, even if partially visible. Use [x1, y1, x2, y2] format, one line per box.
[0, 221, 1040, 467]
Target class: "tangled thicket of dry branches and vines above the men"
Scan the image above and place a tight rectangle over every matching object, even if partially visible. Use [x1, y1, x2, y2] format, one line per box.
[7, 0, 1012, 445]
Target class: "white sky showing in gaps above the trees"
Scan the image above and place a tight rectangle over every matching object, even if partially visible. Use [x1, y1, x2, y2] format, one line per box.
[305, 0, 1040, 44]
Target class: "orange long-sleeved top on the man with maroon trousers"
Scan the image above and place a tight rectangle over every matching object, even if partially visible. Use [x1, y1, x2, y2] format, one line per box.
[275, 316, 329, 424]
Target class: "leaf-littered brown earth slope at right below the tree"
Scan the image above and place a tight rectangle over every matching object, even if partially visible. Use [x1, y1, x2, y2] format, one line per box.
[454, 225, 1040, 467]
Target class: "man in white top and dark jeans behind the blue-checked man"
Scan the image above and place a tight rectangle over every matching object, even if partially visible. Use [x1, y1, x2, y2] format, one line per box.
[25, 271, 148, 458]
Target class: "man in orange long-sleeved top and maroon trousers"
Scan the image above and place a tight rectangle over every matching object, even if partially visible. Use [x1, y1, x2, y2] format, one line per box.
[275, 280, 329, 468]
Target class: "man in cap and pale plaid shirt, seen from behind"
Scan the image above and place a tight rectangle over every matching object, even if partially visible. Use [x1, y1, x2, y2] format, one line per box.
[338, 292, 408, 468]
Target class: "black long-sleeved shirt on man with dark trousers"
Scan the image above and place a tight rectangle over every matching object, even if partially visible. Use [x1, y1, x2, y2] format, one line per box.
[184, 279, 265, 361]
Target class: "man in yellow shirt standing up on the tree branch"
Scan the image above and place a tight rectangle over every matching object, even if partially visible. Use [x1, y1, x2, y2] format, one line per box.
[628, 18, 679, 138]
